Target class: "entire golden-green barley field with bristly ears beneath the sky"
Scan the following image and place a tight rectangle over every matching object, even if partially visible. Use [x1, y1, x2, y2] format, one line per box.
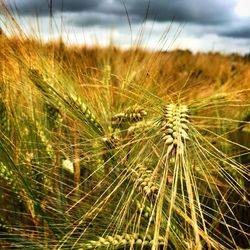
[0, 23, 250, 249]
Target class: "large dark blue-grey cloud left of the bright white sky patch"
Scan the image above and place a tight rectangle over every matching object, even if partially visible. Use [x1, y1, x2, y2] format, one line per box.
[126, 0, 234, 24]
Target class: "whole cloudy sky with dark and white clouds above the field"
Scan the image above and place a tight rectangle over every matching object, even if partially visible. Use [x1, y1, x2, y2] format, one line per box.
[1, 0, 250, 53]
